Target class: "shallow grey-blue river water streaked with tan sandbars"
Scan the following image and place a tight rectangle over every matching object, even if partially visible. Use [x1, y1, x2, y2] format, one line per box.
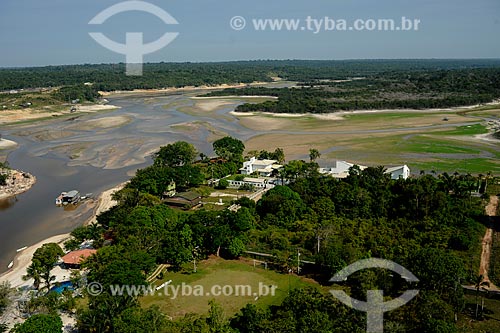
[0, 89, 270, 272]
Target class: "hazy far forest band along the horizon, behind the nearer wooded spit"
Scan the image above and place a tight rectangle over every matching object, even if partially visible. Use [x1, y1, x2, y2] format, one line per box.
[0, 60, 500, 91]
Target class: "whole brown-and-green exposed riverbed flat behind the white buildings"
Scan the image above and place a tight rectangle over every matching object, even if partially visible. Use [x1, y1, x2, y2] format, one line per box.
[238, 108, 500, 175]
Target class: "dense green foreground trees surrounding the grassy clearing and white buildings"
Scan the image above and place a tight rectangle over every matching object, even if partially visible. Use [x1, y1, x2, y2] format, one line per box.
[11, 137, 492, 333]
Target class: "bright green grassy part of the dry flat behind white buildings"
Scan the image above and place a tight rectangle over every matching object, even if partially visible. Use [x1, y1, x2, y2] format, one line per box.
[325, 125, 500, 175]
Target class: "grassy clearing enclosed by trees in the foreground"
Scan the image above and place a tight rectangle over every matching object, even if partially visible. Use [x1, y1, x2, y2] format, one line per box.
[141, 257, 319, 318]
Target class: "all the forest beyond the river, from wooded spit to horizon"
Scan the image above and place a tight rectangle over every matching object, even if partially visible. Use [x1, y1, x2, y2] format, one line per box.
[0, 60, 500, 113]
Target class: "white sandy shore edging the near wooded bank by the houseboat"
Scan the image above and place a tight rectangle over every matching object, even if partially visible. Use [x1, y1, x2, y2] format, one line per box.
[0, 183, 126, 288]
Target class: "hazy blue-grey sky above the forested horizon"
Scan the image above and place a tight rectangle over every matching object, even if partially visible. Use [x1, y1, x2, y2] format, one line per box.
[0, 0, 500, 67]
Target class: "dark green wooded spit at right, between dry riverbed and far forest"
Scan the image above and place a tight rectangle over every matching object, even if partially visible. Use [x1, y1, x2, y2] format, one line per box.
[205, 68, 500, 113]
